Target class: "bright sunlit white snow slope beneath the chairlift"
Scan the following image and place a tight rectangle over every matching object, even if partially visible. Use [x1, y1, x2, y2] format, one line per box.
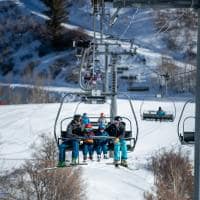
[0, 99, 194, 200]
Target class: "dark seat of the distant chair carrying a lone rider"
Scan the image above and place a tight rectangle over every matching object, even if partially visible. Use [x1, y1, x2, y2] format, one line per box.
[143, 111, 174, 121]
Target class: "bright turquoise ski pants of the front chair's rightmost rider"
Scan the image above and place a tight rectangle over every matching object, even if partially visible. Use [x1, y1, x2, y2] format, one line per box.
[114, 139, 127, 161]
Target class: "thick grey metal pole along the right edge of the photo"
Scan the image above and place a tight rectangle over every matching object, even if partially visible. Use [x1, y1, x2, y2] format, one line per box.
[194, 8, 200, 200]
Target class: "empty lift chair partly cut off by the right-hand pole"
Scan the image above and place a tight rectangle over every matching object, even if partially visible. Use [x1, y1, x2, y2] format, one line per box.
[177, 100, 195, 145]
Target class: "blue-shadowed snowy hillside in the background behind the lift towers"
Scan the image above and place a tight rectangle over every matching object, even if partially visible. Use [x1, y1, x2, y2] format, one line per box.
[0, 0, 196, 93]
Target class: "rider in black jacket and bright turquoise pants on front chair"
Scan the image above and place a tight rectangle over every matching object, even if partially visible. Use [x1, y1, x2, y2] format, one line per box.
[106, 116, 128, 167]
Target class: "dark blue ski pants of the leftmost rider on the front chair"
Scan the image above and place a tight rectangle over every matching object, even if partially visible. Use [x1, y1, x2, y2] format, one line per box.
[59, 140, 79, 161]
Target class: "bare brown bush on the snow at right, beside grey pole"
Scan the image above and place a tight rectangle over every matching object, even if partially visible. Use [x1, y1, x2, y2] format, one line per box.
[145, 150, 193, 200]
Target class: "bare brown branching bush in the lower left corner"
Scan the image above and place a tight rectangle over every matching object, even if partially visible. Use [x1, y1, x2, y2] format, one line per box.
[0, 135, 86, 200]
